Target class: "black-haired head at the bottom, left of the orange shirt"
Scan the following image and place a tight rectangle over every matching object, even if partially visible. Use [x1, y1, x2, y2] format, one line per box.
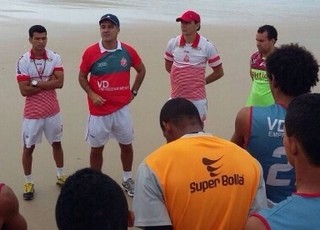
[56, 168, 129, 230]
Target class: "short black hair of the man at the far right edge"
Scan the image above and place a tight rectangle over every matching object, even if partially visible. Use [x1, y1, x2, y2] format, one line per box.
[285, 93, 320, 167]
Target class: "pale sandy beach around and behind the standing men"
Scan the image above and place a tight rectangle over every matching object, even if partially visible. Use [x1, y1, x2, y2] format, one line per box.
[0, 4, 320, 230]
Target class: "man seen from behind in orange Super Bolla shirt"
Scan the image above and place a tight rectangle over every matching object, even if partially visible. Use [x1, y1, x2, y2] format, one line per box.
[133, 98, 266, 230]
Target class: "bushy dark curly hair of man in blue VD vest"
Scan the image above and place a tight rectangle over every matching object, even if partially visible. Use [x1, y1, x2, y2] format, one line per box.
[266, 43, 319, 97]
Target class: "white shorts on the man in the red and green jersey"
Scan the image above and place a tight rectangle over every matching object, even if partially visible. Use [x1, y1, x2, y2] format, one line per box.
[86, 105, 133, 148]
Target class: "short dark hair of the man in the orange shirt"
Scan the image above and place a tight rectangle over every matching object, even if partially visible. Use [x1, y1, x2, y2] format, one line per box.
[160, 97, 202, 130]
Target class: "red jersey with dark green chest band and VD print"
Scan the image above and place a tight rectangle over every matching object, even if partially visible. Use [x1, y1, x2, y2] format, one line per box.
[80, 41, 141, 116]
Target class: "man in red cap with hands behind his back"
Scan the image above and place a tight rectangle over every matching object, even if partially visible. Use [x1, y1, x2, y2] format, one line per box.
[164, 10, 224, 121]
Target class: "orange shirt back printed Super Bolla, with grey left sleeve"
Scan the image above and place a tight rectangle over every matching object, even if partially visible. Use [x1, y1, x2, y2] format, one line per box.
[134, 133, 261, 230]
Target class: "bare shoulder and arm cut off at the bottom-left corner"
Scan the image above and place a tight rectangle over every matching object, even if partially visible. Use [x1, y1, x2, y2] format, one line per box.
[0, 185, 27, 230]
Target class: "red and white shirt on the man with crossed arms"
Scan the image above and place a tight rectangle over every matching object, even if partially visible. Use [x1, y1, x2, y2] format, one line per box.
[16, 50, 63, 119]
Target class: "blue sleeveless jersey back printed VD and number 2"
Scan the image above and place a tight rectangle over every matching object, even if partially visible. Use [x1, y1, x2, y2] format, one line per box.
[247, 104, 295, 203]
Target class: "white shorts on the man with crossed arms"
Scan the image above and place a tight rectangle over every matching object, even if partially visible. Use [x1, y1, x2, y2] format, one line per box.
[22, 113, 62, 148]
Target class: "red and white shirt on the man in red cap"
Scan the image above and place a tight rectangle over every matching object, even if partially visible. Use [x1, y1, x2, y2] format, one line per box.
[164, 34, 222, 100]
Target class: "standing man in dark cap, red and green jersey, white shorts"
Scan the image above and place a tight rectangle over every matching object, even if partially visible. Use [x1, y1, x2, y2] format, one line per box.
[79, 14, 146, 196]
